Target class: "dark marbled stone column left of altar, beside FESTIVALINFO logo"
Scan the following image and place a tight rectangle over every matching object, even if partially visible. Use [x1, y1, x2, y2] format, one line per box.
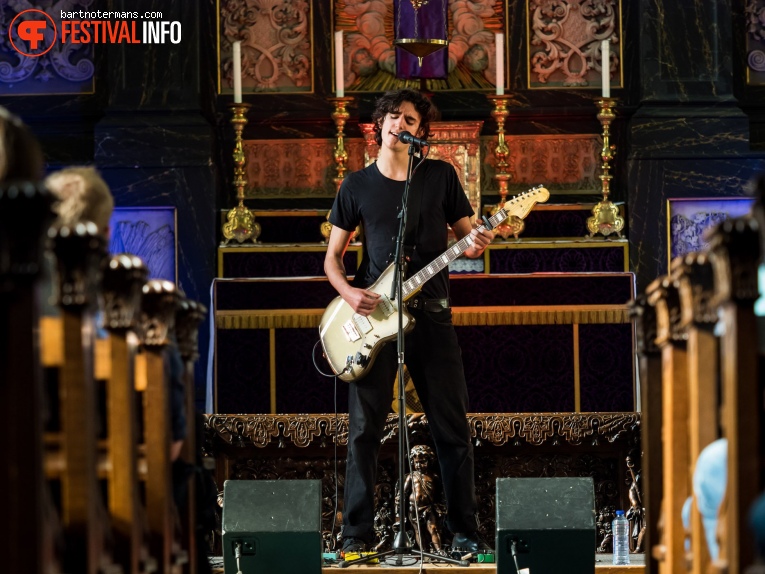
[94, 0, 217, 404]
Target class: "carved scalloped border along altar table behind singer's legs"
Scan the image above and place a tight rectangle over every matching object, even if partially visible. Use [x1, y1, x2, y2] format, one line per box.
[205, 413, 640, 448]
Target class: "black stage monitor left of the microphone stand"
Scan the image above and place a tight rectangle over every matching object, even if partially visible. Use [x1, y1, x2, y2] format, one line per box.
[221, 480, 322, 574]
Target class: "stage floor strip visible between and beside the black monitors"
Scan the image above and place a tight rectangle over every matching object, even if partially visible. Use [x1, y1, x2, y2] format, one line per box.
[211, 554, 645, 574]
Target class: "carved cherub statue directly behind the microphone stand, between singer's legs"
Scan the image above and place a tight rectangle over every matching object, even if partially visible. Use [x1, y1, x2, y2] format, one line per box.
[396, 445, 445, 552]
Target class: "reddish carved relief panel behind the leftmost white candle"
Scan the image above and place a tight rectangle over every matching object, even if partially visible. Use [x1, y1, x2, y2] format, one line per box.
[218, 0, 314, 94]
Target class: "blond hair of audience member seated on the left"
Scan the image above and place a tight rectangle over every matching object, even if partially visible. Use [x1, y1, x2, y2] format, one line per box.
[45, 167, 114, 233]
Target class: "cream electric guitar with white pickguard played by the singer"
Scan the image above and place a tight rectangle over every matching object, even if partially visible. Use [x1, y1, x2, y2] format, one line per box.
[319, 186, 550, 383]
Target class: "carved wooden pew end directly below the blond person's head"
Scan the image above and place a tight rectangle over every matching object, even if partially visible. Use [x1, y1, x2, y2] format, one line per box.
[42, 223, 122, 574]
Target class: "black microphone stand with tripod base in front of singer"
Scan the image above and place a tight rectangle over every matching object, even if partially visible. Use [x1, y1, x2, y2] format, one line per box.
[338, 143, 470, 568]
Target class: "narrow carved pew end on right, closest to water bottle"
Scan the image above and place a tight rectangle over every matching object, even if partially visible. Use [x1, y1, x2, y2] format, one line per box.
[630, 295, 663, 574]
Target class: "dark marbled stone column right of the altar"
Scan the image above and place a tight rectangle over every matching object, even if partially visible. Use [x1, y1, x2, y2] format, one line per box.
[623, 0, 763, 292]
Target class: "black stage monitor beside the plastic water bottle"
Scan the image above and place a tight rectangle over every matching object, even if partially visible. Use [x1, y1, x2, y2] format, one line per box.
[496, 477, 596, 574]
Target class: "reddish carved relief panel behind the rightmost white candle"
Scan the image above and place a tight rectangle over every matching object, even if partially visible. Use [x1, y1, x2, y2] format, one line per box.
[527, 0, 621, 89]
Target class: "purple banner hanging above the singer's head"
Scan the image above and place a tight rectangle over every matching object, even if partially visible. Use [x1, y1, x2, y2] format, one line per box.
[393, 0, 449, 80]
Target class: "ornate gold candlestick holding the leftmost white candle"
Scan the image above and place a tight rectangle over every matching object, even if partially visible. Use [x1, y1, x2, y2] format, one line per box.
[223, 104, 260, 244]
